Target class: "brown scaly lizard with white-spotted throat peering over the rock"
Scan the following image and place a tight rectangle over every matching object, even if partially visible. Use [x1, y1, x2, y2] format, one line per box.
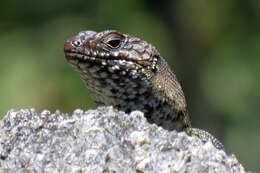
[64, 30, 224, 150]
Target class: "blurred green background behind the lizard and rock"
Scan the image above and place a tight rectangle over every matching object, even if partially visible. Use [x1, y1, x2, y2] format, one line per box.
[0, 0, 260, 171]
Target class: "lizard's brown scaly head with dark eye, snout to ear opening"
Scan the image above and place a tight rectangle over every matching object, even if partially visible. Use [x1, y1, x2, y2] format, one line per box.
[64, 30, 160, 77]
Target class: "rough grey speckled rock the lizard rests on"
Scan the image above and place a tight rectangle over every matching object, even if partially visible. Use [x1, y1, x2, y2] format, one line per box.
[0, 107, 245, 173]
